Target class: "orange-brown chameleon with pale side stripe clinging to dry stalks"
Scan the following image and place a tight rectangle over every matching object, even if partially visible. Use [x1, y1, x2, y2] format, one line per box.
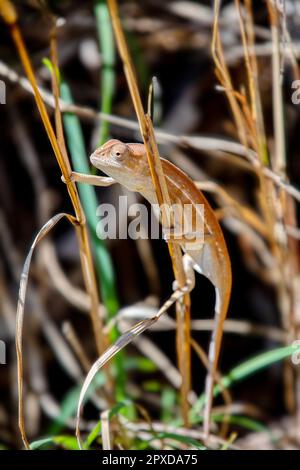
[71, 139, 232, 436]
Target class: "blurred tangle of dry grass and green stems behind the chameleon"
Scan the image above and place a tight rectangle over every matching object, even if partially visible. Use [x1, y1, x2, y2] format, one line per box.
[0, 0, 300, 449]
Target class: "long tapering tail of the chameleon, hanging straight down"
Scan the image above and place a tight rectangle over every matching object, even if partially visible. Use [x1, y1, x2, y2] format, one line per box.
[203, 288, 229, 438]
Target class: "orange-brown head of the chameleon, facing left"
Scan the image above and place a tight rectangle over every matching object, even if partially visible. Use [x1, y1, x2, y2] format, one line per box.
[90, 139, 150, 191]
